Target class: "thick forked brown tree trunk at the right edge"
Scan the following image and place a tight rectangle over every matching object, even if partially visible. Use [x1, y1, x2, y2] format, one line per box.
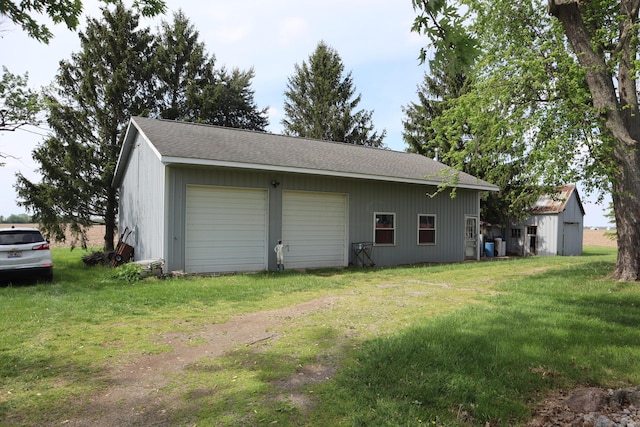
[549, 0, 640, 281]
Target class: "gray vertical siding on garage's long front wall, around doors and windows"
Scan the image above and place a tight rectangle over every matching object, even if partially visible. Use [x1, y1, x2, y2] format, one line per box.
[162, 166, 479, 271]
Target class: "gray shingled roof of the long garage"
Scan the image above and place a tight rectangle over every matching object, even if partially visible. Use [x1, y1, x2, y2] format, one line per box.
[114, 117, 497, 191]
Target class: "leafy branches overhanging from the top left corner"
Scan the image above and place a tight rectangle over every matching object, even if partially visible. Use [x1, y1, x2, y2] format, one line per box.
[0, 0, 166, 43]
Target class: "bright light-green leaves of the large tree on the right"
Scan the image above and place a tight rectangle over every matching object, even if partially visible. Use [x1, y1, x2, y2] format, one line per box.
[405, 0, 636, 221]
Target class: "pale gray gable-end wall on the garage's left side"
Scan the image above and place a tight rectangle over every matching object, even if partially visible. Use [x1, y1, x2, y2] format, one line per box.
[118, 136, 165, 260]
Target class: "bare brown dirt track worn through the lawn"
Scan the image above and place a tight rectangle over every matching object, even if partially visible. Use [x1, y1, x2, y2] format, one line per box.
[62, 296, 336, 427]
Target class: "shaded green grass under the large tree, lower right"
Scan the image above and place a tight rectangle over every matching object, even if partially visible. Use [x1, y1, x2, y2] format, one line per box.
[324, 263, 640, 425]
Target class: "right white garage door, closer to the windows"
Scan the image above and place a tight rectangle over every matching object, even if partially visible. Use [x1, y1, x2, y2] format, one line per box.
[282, 191, 348, 268]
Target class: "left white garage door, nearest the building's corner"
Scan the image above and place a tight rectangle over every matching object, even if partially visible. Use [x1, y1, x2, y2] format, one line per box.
[185, 186, 267, 273]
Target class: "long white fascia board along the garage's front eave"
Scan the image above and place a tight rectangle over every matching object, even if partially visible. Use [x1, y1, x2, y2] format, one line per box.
[161, 157, 498, 191]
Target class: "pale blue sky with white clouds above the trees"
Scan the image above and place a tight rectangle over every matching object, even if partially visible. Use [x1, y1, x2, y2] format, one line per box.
[0, 0, 608, 226]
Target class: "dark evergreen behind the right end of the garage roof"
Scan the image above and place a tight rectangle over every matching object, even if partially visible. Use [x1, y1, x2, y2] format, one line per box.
[403, 54, 550, 227]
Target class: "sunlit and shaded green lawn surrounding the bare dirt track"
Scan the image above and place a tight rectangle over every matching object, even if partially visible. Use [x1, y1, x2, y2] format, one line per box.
[0, 248, 640, 426]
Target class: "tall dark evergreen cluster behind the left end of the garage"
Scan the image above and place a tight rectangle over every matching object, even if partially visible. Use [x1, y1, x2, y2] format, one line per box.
[16, 2, 267, 251]
